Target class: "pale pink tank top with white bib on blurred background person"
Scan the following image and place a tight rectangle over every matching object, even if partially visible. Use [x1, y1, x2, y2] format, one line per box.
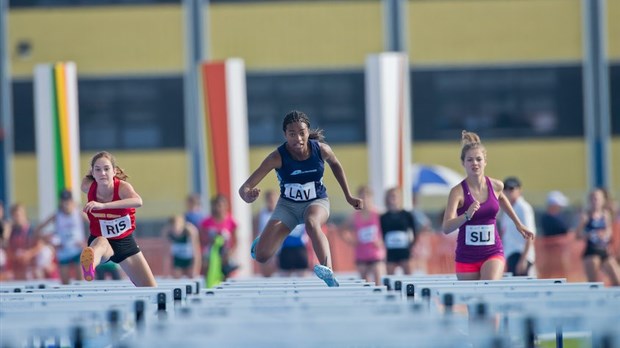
[353, 211, 385, 262]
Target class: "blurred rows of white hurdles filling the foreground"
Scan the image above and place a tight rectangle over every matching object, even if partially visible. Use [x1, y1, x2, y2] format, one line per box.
[0, 274, 620, 348]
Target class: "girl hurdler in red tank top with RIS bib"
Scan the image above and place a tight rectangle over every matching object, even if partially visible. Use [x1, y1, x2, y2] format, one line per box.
[80, 151, 157, 286]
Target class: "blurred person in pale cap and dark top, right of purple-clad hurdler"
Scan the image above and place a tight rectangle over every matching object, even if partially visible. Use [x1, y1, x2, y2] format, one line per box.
[537, 191, 573, 278]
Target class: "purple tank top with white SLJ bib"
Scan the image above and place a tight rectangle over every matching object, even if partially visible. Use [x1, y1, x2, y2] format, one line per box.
[456, 176, 504, 263]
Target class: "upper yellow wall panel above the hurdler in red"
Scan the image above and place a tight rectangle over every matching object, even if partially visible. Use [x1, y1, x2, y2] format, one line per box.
[8, 5, 184, 77]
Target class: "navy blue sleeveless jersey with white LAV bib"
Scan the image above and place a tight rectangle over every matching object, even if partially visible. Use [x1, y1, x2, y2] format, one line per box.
[276, 140, 327, 202]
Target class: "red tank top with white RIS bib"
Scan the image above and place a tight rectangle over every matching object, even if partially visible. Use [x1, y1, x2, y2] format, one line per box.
[88, 177, 136, 239]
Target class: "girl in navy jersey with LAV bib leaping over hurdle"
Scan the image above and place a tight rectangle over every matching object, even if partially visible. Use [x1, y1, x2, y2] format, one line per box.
[239, 111, 363, 286]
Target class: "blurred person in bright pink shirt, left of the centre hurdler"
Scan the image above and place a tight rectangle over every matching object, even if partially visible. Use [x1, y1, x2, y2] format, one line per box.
[200, 194, 238, 278]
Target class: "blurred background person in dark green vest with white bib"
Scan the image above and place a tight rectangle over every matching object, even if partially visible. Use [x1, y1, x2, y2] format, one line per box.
[162, 215, 202, 278]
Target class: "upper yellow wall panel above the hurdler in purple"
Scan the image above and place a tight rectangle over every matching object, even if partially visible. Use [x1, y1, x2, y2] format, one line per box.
[408, 0, 582, 65]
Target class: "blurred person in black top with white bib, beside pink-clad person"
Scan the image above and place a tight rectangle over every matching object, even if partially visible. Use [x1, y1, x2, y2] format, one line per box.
[379, 187, 416, 275]
